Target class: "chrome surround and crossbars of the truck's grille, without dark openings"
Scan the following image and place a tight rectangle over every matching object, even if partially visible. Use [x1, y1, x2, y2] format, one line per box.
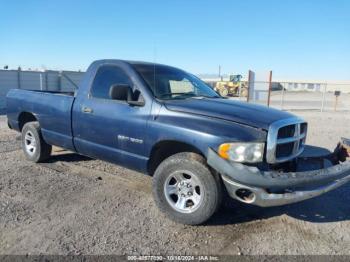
[266, 117, 307, 164]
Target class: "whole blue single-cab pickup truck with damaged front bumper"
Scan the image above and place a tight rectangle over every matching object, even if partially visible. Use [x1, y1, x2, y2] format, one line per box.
[7, 60, 350, 224]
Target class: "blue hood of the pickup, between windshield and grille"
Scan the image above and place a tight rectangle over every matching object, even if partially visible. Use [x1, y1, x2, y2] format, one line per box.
[164, 98, 294, 130]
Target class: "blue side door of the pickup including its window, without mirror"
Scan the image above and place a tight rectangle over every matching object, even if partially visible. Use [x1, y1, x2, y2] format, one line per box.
[73, 65, 150, 170]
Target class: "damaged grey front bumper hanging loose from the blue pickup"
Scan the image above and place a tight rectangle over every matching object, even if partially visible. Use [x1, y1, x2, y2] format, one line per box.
[207, 139, 350, 207]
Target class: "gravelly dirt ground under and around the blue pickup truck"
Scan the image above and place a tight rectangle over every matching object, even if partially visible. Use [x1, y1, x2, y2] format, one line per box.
[0, 112, 350, 255]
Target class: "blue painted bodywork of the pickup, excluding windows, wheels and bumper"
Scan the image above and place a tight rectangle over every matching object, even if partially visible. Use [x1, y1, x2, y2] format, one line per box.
[7, 60, 296, 172]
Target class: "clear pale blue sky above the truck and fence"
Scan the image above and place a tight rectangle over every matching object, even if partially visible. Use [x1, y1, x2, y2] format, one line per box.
[0, 0, 350, 80]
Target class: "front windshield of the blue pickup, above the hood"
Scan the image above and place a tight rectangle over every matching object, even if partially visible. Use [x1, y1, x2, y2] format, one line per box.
[133, 64, 220, 99]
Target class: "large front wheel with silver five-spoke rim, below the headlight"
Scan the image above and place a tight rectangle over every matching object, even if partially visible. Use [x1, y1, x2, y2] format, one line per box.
[153, 153, 222, 225]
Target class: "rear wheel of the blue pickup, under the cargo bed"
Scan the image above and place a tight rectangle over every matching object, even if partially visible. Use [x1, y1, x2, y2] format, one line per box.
[22, 122, 52, 163]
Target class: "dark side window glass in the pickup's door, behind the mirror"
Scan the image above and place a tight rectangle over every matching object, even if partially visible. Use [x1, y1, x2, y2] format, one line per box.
[90, 65, 131, 99]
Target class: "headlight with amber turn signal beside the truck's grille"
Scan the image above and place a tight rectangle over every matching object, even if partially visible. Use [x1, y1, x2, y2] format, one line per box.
[218, 143, 265, 163]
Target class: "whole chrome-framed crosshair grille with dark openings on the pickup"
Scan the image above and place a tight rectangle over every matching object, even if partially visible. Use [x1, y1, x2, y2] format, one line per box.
[266, 118, 307, 164]
